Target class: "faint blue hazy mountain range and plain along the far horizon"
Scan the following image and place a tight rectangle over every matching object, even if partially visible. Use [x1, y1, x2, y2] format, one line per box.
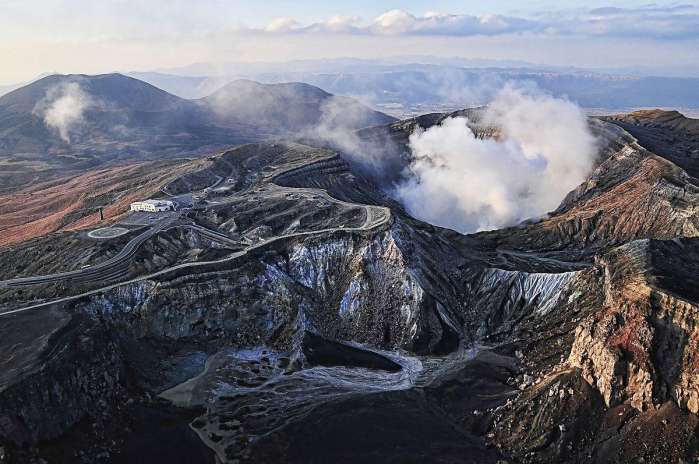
[124, 57, 699, 117]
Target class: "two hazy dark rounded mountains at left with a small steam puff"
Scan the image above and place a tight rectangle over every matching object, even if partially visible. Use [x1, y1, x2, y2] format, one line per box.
[0, 74, 394, 190]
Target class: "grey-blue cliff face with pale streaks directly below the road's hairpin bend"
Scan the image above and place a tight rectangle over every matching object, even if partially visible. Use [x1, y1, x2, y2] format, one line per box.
[77, 227, 458, 352]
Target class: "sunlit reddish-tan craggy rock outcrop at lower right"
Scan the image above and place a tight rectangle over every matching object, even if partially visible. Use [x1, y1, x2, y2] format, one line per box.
[569, 240, 699, 413]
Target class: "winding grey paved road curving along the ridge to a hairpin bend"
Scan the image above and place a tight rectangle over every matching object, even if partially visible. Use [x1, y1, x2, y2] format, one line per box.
[0, 183, 391, 317]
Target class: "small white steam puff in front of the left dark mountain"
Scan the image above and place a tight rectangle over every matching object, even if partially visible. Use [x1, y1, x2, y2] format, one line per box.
[34, 82, 95, 143]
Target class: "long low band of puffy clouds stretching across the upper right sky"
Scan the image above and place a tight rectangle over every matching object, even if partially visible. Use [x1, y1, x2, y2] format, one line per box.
[264, 5, 699, 39]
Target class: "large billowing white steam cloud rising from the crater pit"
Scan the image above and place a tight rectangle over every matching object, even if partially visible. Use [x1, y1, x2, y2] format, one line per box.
[394, 85, 596, 233]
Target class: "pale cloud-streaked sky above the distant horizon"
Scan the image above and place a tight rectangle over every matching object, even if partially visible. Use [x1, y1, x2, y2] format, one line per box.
[0, 0, 699, 84]
